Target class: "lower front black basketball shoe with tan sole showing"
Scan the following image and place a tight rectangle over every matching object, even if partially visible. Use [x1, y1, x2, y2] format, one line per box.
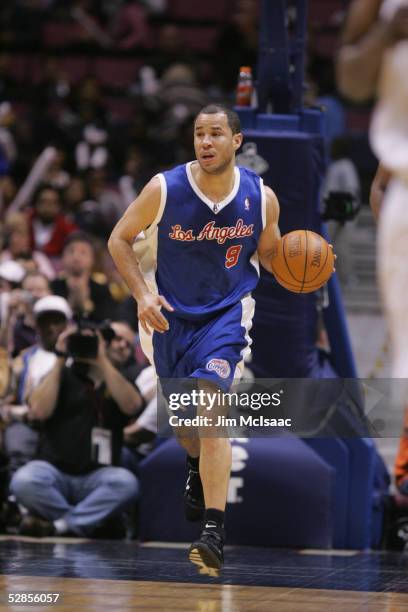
[188, 521, 225, 578]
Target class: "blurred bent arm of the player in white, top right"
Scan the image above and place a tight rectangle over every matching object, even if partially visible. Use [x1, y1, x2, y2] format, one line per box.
[337, 0, 408, 102]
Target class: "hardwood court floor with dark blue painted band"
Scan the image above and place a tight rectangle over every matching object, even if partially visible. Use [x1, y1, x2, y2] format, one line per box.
[0, 537, 408, 612]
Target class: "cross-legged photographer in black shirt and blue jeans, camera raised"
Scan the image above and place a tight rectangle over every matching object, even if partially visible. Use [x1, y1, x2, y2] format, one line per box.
[10, 316, 144, 537]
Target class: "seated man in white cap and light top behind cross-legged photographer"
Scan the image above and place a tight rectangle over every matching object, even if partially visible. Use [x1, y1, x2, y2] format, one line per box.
[2, 295, 72, 474]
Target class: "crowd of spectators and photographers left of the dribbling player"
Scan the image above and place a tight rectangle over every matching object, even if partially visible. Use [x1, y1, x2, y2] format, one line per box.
[0, 0, 249, 536]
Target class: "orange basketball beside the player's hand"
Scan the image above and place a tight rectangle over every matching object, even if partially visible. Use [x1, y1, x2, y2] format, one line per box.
[271, 230, 335, 293]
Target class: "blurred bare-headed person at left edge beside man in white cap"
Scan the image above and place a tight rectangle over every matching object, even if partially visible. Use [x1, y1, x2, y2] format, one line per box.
[0, 272, 51, 356]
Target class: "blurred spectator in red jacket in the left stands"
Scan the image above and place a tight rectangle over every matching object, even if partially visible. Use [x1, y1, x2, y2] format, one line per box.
[28, 185, 77, 257]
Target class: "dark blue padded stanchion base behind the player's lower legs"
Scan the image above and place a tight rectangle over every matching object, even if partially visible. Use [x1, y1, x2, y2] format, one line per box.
[140, 437, 335, 548]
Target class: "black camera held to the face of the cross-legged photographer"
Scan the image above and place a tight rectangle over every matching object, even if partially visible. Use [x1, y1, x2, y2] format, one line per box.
[67, 319, 115, 359]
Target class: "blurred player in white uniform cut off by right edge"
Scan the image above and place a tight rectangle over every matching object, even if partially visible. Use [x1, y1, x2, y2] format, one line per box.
[338, 0, 408, 493]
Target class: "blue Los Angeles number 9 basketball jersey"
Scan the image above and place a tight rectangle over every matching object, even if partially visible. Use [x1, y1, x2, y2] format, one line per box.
[135, 162, 266, 320]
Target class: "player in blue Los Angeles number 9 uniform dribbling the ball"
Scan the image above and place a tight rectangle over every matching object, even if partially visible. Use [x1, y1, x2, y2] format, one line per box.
[109, 105, 280, 575]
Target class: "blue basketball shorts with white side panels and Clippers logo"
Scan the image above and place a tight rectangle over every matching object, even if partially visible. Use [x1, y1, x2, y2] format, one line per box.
[140, 294, 255, 391]
